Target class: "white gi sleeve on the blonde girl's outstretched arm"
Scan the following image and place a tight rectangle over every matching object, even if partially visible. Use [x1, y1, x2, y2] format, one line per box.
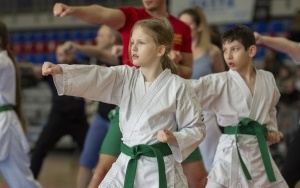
[53, 65, 126, 105]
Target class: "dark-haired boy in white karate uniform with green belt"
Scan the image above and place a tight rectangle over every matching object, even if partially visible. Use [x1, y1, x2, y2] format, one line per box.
[189, 26, 288, 188]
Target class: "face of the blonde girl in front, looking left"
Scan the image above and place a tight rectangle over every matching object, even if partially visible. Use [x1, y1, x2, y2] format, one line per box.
[129, 26, 160, 67]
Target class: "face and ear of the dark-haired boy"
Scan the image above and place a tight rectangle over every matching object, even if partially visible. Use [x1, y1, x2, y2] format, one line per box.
[223, 41, 256, 72]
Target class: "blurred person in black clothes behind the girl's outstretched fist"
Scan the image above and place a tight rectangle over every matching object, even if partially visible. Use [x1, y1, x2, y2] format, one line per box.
[30, 41, 89, 179]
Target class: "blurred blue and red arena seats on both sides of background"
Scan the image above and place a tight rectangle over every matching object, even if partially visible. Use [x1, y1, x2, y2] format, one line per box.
[10, 20, 291, 63]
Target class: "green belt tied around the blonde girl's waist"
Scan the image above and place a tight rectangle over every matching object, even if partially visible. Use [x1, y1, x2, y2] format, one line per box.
[121, 143, 172, 188]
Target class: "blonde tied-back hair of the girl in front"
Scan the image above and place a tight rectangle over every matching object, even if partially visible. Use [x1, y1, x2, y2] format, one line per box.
[128, 17, 178, 74]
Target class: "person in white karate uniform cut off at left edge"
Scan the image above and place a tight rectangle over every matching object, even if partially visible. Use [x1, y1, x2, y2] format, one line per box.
[0, 21, 41, 188]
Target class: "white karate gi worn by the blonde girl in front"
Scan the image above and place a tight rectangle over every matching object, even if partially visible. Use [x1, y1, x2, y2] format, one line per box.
[54, 65, 205, 188]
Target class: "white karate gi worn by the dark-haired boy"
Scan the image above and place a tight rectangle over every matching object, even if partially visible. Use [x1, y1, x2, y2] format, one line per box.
[189, 70, 287, 188]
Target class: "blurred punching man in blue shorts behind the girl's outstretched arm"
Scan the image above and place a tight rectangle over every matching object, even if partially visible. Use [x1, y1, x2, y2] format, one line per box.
[59, 25, 121, 188]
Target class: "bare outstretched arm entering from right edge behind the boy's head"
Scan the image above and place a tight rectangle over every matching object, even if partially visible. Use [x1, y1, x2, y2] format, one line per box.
[254, 32, 300, 63]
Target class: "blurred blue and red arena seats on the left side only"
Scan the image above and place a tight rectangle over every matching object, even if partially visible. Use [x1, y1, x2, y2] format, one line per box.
[9, 28, 97, 64]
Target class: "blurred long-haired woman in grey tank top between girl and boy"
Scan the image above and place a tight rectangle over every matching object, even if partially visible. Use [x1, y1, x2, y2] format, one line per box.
[179, 7, 225, 177]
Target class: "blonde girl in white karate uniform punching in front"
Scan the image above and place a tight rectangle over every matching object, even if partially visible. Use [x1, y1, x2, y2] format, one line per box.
[42, 18, 205, 188]
